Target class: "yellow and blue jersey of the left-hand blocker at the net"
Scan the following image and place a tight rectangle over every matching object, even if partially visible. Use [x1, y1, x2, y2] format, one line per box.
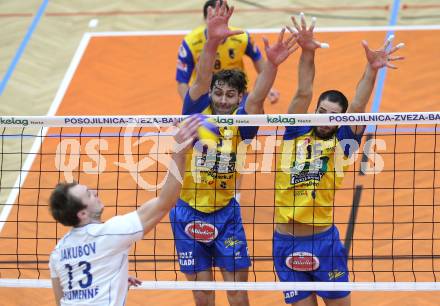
[180, 95, 257, 213]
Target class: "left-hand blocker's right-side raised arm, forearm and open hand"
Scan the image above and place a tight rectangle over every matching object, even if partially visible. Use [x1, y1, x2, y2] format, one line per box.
[245, 28, 298, 114]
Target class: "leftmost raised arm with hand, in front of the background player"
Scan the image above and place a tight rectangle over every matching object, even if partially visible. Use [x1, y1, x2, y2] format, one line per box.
[189, 1, 243, 101]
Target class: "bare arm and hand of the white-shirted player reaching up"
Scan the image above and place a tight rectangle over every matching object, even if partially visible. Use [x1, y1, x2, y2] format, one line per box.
[137, 116, 200, 233]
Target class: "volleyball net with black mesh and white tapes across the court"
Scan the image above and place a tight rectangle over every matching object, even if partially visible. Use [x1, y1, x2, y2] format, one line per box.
[0, 112, 440, 291]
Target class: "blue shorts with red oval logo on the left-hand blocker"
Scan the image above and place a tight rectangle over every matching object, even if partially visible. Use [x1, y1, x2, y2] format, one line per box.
[170, 199, 251, 273]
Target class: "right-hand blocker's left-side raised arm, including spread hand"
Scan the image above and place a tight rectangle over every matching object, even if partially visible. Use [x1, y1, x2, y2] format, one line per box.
[287, 13, 328, 114]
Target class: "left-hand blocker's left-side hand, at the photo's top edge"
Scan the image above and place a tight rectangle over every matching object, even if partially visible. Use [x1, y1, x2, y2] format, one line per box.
[206, 1, 243, 41]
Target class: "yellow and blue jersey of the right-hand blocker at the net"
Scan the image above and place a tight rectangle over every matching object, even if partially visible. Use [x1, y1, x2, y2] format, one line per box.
[275, 126, 362, 226]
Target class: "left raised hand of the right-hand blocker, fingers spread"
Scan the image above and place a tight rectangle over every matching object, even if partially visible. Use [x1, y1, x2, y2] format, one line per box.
[287, 13, 329, 51]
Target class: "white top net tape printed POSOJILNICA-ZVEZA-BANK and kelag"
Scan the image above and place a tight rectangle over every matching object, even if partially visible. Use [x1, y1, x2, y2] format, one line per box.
[0, 112, 440, 127]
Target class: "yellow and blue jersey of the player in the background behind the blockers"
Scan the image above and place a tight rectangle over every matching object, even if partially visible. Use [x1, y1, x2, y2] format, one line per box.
[176, 25, 261, 85]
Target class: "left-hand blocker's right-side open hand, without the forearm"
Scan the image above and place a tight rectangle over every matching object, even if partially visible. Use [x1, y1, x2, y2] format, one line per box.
[263, 28, 299, 66]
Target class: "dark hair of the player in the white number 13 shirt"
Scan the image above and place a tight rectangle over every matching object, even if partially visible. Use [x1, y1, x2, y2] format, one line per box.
[49, 182, 87, 226]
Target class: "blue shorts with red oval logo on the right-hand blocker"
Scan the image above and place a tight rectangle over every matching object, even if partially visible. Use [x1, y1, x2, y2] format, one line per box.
[273, 225, 350, 304]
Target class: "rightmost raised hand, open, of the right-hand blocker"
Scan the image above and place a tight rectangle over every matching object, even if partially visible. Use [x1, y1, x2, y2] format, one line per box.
[362, 35, 405, 70]
